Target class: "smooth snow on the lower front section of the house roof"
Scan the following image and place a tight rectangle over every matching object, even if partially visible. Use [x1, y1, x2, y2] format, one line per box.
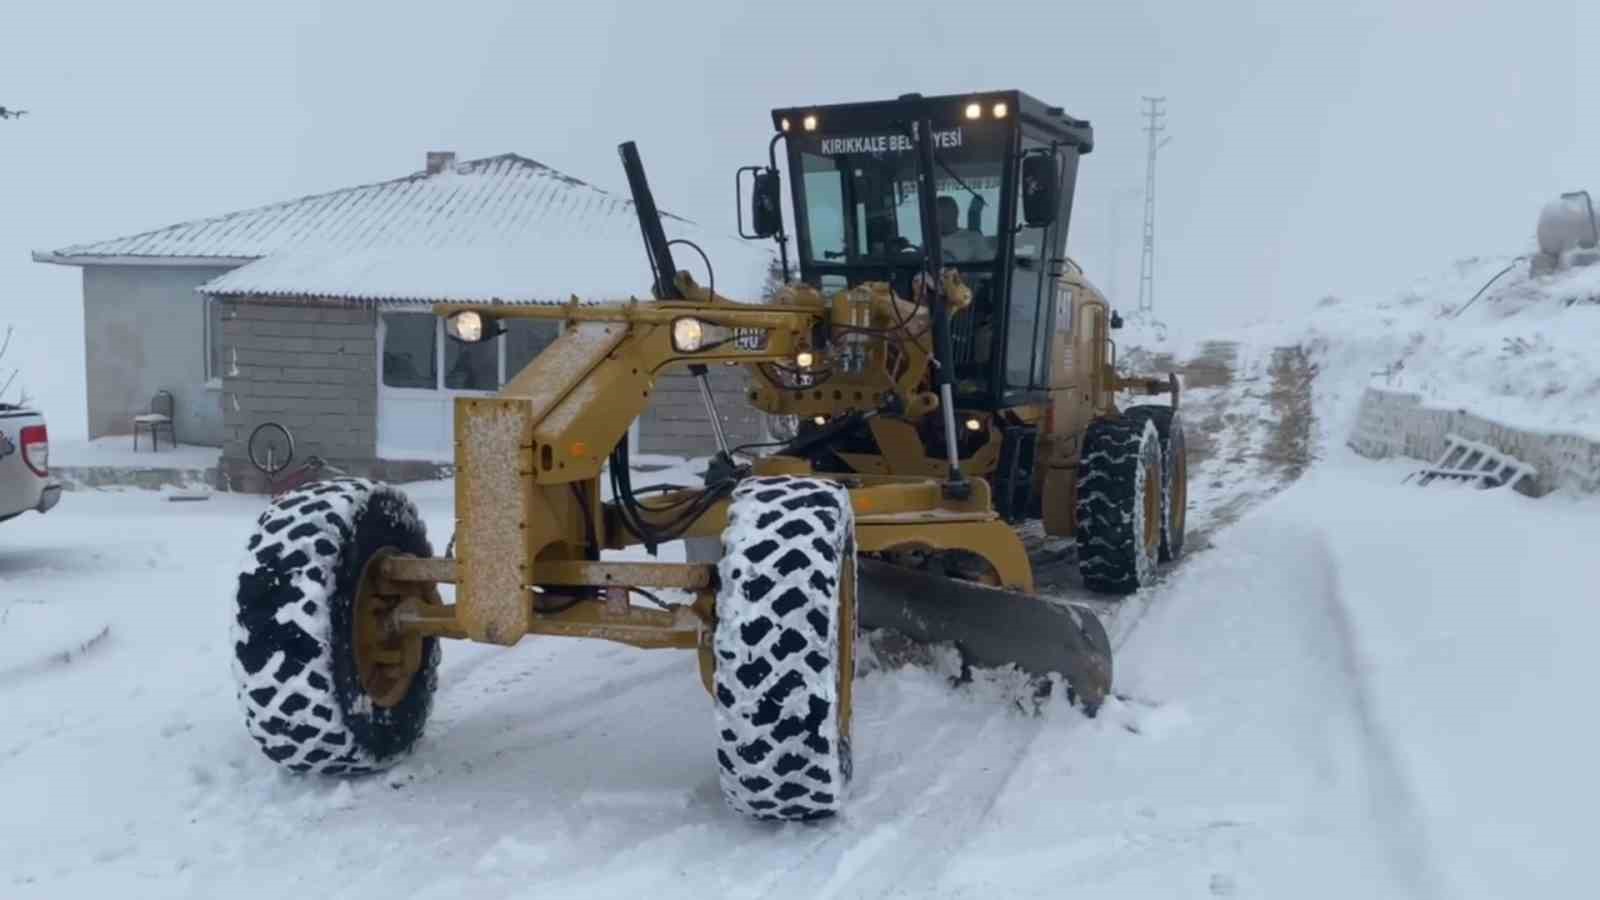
[200, 232, 766, 303]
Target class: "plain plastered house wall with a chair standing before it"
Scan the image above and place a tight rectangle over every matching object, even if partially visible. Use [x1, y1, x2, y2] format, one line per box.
[83, 266, 229, 447]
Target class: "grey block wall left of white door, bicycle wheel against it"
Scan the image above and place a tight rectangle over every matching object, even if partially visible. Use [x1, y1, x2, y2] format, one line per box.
[221, 299, 380, 492]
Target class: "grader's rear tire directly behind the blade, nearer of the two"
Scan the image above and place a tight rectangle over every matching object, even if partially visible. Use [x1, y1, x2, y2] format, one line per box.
[1077, 416, 1162, 594]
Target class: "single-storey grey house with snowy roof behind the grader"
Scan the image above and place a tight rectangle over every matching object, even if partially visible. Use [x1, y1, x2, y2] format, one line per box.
[34, 152, 771, 490]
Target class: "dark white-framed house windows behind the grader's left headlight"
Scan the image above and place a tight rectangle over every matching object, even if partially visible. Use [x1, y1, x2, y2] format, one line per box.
[382, 312, 560, 391]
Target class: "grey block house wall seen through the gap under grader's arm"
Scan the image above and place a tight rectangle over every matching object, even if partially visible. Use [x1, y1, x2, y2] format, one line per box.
[638, 365, 768, 456]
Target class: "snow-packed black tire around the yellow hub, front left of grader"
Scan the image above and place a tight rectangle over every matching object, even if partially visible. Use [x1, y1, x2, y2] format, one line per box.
[234, 479, 438, 775]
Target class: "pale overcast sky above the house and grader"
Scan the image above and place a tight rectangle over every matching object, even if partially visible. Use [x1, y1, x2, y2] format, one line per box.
[0, 0, 1600, 436]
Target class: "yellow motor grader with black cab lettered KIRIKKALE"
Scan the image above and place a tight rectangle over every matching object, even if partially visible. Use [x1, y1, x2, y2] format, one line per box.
[234, 91, 1187, 820]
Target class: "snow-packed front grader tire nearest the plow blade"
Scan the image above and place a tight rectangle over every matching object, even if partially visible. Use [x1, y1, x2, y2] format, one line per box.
[714, 477, 856, 820]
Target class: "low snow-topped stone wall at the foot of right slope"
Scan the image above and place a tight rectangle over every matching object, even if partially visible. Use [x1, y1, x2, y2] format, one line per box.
[1349, 388, 1600, 493]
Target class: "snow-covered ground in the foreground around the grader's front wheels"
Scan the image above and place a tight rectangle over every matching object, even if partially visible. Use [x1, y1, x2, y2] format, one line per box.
[0, 445, 1600, 898]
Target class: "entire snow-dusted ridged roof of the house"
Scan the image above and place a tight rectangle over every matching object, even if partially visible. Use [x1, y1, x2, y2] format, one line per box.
[34, 154, 770, 303]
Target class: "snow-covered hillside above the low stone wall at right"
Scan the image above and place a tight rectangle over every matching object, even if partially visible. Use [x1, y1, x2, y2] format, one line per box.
[1246, 256, 1600, 439]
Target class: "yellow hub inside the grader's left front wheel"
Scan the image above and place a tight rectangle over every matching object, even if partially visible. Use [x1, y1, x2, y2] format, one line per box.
[352, 548, 438, 706]
